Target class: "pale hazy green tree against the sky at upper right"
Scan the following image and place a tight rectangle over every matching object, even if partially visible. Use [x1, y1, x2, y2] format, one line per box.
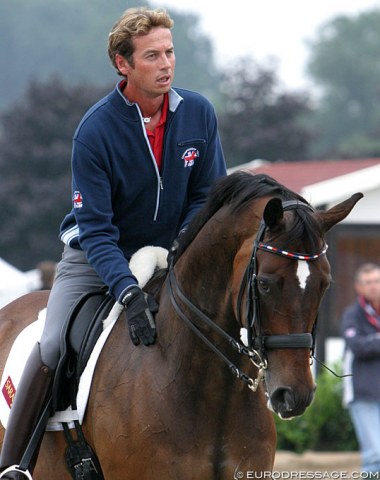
[308, 9, 380, 158]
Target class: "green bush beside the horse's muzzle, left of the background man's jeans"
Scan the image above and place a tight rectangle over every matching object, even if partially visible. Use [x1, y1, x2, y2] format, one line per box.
[275, 370, 358, 452]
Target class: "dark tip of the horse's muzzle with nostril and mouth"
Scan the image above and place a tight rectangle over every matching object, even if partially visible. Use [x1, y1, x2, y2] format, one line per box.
[268, 386, 316, 420]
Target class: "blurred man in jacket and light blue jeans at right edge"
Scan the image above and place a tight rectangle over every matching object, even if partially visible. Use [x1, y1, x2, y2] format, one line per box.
[342, 263, 380, 473]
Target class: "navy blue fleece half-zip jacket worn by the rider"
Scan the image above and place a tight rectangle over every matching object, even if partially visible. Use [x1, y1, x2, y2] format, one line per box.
[60, 82, 226, 300]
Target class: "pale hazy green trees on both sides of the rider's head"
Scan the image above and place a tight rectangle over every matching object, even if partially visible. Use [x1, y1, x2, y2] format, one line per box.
[0, 0, 219, 107]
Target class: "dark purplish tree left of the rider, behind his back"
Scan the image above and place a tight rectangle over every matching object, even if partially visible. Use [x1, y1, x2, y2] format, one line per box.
[0, 78, 104, 269]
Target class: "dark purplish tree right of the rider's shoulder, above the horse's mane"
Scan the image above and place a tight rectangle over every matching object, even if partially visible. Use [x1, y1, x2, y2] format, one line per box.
[220, 58, 312, 167]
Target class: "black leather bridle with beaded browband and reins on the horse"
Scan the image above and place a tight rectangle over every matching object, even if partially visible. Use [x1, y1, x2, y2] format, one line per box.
[169, 200, 327, 391]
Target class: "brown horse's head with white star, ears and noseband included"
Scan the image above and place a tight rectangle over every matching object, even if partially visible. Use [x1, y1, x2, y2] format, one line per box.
[238, 194, 362, 418]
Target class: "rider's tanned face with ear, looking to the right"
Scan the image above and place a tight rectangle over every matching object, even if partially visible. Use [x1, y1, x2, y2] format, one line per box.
[116, 27, 175, 97]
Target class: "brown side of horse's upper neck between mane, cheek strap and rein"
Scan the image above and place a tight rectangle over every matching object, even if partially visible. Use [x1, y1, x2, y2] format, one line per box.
[170, 207, 261, 328]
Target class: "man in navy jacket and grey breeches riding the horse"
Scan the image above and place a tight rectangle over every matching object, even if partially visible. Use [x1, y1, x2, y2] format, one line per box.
[0, 8, 226, 479]
